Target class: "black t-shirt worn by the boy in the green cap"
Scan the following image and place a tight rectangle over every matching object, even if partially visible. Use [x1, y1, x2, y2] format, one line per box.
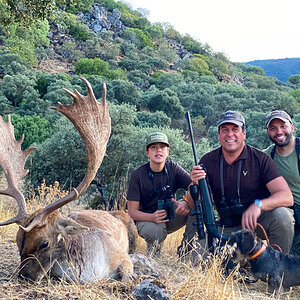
[127, 161, 191, 213]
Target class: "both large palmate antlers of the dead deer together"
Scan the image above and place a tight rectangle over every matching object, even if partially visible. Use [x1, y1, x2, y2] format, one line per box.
[0, 78, 111, 232]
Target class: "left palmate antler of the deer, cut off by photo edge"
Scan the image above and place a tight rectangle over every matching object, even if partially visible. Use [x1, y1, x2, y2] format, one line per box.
[0, 115, 36, 226]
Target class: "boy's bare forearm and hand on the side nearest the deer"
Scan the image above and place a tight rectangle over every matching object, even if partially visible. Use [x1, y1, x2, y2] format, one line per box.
[127, 200, 169, 223]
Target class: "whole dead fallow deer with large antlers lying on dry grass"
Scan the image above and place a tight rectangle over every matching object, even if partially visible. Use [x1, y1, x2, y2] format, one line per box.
[0, 78, 137, 282]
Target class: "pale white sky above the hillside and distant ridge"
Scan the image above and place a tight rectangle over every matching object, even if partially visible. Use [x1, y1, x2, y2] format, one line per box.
[124, 0, 300, 62]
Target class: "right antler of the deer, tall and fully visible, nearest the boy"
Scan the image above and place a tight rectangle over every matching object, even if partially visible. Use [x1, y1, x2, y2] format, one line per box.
[26, 77, 111, 231]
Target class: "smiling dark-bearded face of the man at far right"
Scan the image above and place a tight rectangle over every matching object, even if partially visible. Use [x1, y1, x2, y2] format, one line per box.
[267, 119, 294, 147]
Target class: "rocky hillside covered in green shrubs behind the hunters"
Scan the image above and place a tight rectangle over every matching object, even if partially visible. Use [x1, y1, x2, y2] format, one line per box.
[0, 0, 300, 202]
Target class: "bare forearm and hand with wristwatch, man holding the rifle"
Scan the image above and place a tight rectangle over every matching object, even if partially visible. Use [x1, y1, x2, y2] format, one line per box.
[242, 176, 294, 230]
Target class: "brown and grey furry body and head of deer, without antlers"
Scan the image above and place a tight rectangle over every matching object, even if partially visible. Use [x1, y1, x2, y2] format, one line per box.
[17, 210, 137, 283]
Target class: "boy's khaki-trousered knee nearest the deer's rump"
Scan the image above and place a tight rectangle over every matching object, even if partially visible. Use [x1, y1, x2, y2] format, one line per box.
[136, 222, 167, 244]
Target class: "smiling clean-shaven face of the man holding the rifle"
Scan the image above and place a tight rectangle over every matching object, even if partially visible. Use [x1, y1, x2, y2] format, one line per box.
[218, 123, 246, 154]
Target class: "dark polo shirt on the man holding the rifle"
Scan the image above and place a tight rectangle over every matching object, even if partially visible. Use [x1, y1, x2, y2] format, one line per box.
[200, 145, 281, 211]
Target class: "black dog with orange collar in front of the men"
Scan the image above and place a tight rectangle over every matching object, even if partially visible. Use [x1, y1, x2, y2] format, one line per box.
[228, 230, 300, 291]
